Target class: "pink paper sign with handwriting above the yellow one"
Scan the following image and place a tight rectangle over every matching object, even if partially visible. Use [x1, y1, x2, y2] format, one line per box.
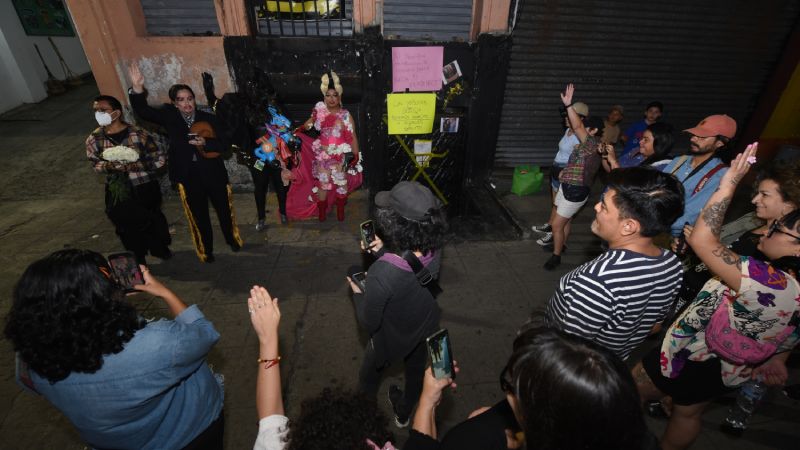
[392, 47, 444, 92]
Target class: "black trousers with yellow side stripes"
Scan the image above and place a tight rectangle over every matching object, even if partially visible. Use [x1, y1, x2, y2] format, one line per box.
[179, 165, 242, 261]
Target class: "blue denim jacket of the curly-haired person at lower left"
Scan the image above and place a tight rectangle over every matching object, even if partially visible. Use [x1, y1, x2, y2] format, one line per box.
[31, 305, 223, 449]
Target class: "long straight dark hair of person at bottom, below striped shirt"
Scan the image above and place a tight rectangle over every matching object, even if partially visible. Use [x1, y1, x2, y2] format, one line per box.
[506, 326, 647, 450]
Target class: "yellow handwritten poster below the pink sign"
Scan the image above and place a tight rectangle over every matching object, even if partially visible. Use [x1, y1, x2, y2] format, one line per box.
[387, 93, 436, 134]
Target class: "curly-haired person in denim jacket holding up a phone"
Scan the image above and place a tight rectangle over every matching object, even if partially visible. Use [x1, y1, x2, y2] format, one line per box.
[5, 249, 224, 449]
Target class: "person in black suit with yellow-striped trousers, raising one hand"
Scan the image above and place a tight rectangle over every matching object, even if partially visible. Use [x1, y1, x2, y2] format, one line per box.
[128, 64, 243, 263]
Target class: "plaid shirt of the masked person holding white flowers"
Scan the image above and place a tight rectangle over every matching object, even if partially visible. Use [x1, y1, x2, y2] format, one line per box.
[86, 125, 167, 186]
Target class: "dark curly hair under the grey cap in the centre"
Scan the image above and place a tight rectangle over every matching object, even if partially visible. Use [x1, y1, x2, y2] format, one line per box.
[375, 208, 447, 254]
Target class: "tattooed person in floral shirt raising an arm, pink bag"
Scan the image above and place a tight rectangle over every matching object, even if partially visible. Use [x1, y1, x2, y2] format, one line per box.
[633, 144, 800, 450]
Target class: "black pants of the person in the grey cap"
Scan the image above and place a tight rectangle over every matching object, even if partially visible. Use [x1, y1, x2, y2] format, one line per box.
[358, 340, 428, 418]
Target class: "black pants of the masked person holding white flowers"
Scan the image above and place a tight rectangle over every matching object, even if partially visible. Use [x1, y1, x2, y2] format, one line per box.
[106, 181, 172, 264]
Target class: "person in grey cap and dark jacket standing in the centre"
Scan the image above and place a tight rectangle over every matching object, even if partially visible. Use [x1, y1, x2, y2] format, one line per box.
[348, 181, 447, 428]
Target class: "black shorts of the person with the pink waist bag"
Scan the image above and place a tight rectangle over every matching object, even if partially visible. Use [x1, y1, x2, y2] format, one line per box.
[642, 346, 736, 406]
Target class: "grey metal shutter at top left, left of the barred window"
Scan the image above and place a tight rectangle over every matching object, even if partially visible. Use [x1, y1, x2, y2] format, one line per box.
[142, 0, 220, 36]
